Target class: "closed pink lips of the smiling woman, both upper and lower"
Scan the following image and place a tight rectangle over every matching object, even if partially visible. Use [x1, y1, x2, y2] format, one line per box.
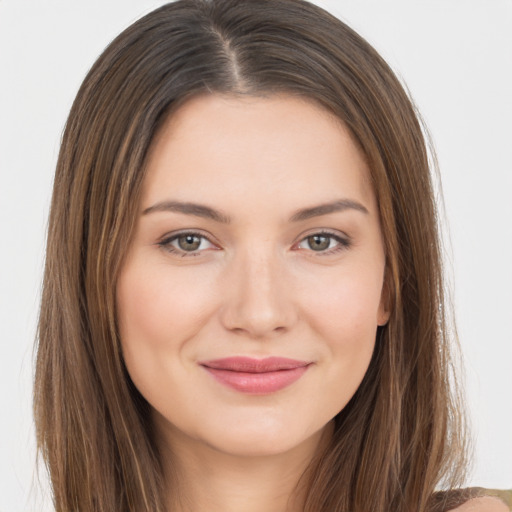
[199, 357, 311, 395]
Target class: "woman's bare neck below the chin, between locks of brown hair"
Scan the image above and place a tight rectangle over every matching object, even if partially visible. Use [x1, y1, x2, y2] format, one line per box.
[161, 424, 332, 512]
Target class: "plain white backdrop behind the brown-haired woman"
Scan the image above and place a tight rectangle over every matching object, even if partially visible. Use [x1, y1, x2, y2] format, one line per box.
[0, 0, 512, 512]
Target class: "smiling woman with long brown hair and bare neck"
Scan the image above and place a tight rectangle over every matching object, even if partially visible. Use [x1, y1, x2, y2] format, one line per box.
[35, 0, 508, 512]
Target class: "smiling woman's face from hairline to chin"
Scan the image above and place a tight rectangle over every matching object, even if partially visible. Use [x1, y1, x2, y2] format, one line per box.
[117, 95, 388, 455]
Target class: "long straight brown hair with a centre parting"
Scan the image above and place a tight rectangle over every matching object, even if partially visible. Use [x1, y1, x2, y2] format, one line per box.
[34, 0, 464, 512]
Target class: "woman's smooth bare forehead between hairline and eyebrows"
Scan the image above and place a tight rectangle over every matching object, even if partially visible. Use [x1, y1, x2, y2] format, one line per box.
[144, 94, 374, 214]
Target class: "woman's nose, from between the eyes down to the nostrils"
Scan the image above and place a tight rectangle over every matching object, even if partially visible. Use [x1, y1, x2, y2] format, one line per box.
[221, 251, 298, 339]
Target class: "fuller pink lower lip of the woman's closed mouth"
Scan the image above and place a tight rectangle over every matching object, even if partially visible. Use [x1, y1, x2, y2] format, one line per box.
[203, 366, 309, 395]
